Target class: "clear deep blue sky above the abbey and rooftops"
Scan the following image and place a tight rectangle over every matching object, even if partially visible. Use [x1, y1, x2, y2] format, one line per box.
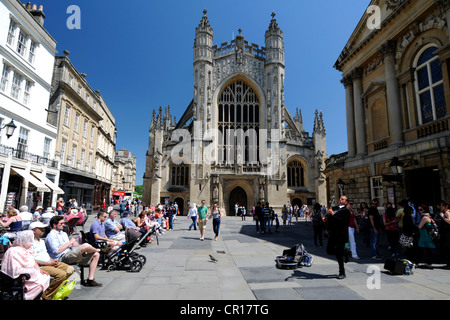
[38, 0, 370, 185]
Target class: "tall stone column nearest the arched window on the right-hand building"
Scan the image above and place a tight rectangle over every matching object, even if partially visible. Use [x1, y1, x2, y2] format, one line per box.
[379, 40, 404, 146]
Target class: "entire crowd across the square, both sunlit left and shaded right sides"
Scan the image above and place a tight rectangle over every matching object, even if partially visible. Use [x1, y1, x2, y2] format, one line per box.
[0, 196, 450, 300]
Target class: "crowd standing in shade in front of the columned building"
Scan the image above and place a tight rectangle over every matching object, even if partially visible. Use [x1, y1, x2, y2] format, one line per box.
[310, 196, 450, 279]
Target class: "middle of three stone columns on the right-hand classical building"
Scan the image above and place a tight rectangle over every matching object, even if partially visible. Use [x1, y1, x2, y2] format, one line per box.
[352, 68, 367, 156]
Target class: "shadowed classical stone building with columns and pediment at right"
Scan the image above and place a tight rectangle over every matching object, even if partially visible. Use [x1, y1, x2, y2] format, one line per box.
[325, 0, 450, 207]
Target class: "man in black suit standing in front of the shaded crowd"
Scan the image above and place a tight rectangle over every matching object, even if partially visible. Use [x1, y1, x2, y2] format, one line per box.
[327, 196, 350, 279]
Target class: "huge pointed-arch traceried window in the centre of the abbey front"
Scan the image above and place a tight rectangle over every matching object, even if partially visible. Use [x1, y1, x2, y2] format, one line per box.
[218, 80, 260, 165]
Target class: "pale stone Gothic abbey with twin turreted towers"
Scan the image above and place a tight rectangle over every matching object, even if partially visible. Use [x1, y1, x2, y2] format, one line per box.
[143, 10, 328, 215]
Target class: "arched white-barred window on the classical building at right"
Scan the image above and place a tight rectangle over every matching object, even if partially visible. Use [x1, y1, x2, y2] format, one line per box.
[415, 45, 447, 124]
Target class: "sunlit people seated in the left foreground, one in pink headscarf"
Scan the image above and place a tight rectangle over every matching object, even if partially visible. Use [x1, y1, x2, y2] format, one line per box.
[0, 199, 101, 300]
